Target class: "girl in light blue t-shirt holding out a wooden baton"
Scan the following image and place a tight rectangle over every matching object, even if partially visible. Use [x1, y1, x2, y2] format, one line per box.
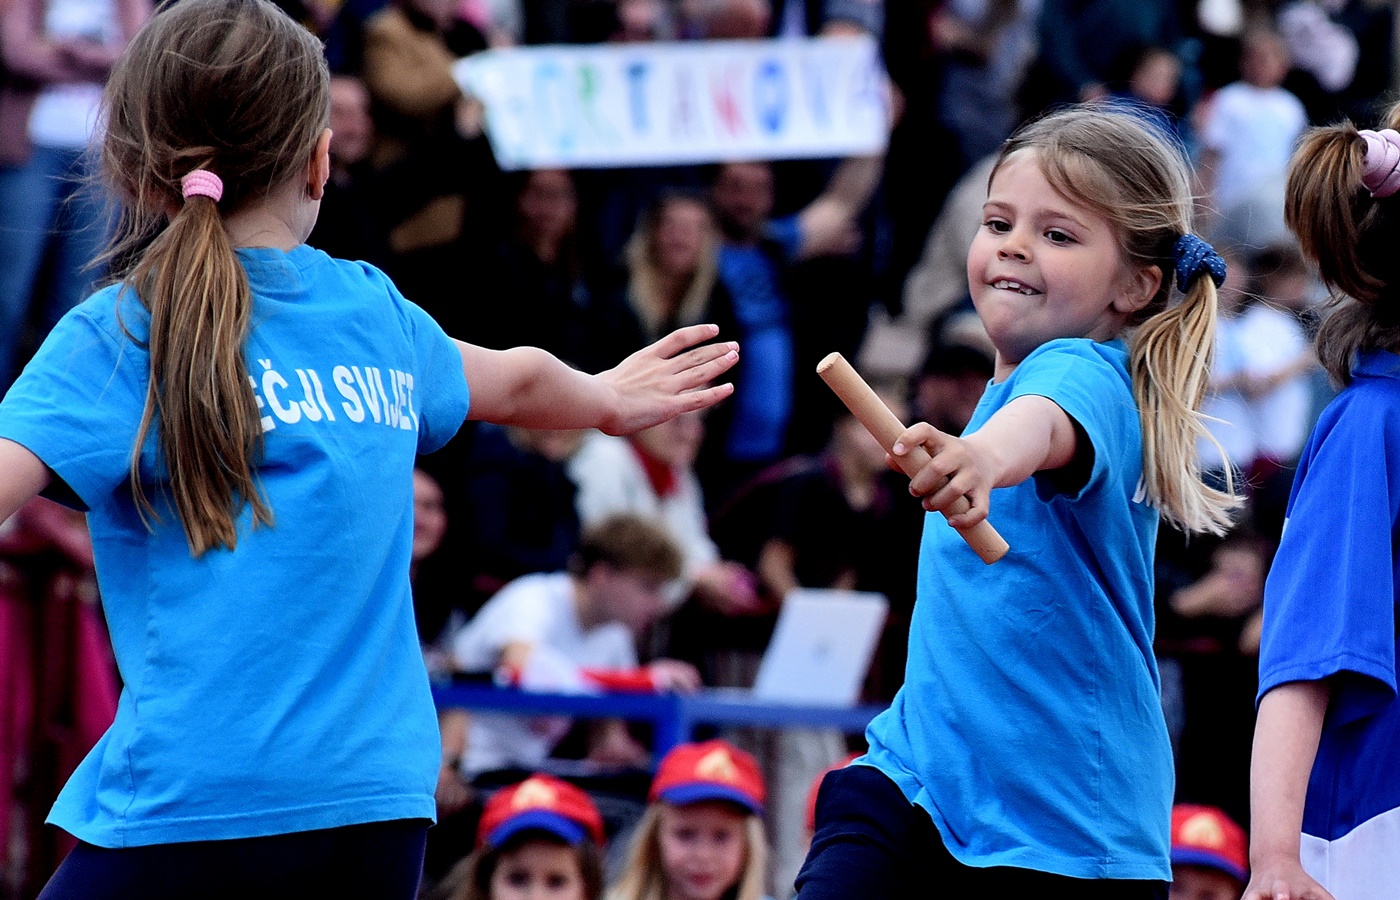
[798, 106, 1233, 900]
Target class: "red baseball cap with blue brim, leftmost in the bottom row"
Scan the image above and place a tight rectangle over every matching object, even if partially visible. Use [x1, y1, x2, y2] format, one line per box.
[476, 775, 603, 847]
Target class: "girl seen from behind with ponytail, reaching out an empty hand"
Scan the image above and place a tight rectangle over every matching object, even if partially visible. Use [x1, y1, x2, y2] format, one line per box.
[0, 0, 738, 899]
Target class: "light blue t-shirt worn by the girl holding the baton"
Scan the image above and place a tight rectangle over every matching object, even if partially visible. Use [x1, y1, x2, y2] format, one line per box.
[862, 339, 1173, 880]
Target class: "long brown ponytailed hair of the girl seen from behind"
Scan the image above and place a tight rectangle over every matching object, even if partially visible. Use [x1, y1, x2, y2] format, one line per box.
[101, 0, 330, 556]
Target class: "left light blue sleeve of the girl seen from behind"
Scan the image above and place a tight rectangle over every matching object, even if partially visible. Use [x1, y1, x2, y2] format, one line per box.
[0, 287, 148, 509]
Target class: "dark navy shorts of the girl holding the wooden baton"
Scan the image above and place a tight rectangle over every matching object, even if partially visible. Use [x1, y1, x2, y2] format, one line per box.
[797, 766, 1168, 900]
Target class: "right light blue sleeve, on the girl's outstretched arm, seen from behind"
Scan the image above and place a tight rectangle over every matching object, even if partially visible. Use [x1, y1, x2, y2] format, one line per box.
[375, 270, 472, 453]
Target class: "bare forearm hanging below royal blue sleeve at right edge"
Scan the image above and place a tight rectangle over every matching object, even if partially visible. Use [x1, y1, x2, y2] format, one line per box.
[1243, 682, 1333, 900]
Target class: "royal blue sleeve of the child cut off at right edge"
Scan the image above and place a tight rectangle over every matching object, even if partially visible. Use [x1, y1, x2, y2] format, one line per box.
[1259, 392, 1400, 724]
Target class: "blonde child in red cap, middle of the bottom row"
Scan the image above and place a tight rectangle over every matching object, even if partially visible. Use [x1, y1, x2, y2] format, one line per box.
[608, 740, 767, 900]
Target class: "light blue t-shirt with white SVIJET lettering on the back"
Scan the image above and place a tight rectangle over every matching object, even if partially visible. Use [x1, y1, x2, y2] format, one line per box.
[0, 246, 468, 847]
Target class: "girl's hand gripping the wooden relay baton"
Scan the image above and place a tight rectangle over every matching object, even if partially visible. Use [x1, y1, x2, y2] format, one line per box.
[892, 421, 1000, 528]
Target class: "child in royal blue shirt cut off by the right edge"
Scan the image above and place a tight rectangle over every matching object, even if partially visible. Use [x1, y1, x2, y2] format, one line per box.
[1245, 114, 1400, 900]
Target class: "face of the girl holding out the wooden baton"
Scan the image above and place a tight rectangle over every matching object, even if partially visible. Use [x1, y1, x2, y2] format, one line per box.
[967, 150, 1162, 381]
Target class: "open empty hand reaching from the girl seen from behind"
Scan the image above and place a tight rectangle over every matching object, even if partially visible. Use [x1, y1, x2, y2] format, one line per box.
[598, 325, 739, 434]
